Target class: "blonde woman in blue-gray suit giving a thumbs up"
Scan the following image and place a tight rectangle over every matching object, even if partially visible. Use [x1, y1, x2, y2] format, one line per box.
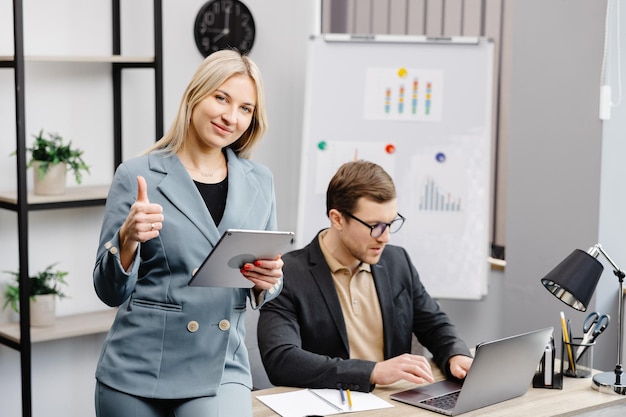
[93, 50, 283, 417]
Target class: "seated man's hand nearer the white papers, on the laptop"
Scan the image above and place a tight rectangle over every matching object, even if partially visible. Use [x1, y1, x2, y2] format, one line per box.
[370, 353, 434, 385]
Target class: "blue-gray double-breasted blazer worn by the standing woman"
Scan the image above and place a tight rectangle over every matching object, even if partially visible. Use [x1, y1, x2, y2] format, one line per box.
[93, 149, 282, 398]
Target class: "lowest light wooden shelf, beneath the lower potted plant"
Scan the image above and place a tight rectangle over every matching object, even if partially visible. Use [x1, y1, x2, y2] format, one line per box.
[0, 309, 117, 344]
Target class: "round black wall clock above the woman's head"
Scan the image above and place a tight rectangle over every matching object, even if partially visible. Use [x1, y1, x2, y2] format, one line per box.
[193, 0, 255, 57]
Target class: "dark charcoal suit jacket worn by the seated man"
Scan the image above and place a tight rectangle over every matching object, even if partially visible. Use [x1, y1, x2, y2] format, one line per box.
[258, 231, 471, 392]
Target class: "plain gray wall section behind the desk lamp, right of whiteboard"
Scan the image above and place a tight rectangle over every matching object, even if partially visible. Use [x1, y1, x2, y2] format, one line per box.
[500, 0, 614, 369]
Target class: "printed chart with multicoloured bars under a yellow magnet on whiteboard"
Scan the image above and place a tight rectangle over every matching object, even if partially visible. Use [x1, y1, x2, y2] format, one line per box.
[364, 67, 444, 122]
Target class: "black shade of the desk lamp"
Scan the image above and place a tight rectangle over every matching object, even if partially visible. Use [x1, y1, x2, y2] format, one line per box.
[541, 249, 604, 311]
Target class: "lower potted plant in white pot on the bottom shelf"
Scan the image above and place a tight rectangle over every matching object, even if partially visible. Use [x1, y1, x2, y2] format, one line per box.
[3, 264, 68, 327]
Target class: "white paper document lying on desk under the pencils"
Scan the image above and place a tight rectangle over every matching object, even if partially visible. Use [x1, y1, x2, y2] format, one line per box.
[257, 388, 393, 417]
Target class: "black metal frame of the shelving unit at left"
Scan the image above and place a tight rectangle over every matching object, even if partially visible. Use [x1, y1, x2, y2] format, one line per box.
[0, 0, 163, 417]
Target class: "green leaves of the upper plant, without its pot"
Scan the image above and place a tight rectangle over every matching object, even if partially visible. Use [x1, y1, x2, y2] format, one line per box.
[26, 129, 89, 184]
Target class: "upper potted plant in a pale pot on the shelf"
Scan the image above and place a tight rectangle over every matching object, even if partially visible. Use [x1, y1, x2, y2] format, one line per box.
[26, 129, 89, 195]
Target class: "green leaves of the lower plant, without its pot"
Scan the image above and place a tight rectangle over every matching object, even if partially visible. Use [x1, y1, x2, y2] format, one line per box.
[2, 264, 68, 313]
